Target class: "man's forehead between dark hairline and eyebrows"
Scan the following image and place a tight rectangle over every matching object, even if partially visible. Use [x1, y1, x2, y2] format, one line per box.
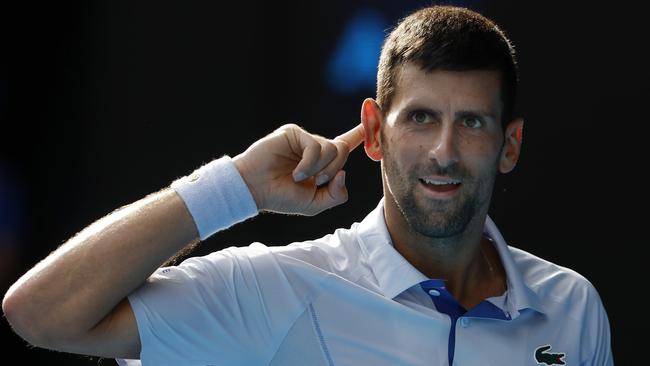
[391, 63, 502, 115]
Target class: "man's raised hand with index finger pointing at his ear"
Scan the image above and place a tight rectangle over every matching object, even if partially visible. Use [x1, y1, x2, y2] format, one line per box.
[233, 124, 364, 215]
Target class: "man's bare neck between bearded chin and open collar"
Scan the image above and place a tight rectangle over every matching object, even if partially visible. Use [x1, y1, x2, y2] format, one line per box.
[384, 197, 505, 309]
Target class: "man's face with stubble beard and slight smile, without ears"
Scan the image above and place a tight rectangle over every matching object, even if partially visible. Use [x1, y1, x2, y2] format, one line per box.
[381, 64, 503, 238]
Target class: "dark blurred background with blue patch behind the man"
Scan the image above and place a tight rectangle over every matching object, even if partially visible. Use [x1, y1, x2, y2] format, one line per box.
[0, 0, 650, 365]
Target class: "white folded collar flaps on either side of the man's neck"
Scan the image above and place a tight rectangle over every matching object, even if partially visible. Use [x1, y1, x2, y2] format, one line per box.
[357, 198, 544, 317]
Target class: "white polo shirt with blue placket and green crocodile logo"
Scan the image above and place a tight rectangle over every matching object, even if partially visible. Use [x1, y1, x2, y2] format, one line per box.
[118, 174, 613, 366]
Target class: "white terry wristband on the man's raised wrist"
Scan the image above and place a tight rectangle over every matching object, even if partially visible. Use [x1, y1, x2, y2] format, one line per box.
[171, 156, 257, 240]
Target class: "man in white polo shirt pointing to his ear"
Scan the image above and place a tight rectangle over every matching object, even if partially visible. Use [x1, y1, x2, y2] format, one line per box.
[3, 6, 613, 366]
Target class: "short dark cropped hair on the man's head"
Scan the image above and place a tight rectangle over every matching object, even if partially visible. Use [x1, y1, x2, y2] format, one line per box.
[377, 6, 518, 128]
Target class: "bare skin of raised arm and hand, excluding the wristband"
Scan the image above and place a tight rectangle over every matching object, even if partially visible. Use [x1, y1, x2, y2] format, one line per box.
[2, 125, 363, 358]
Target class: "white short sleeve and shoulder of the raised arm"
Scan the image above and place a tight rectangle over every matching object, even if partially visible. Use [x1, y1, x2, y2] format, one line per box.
[128, 243, 316, 366]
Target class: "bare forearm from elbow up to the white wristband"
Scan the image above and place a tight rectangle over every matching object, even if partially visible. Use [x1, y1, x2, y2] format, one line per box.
[3, 189, 198, 340]
